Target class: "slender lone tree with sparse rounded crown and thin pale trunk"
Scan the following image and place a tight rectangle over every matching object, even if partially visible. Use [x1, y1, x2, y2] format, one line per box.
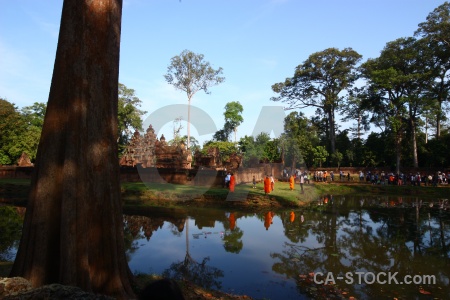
[164, 50, 225, 151]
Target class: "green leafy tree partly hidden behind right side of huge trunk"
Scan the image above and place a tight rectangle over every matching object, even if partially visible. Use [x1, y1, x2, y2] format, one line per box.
[117, 83, 147, 151]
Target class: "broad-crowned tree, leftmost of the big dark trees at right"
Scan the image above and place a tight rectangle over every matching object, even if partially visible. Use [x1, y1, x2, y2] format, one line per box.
[271, 48, 362, 153]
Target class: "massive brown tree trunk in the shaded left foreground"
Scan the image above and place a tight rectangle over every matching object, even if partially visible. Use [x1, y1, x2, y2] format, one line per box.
[11, 0, 133, 299]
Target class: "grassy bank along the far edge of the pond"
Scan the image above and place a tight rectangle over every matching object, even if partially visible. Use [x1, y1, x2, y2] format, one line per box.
[0, 179, 450, 207]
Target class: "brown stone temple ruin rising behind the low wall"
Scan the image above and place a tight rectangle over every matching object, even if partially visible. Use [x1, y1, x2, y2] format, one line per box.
[119, 125, 192, 169]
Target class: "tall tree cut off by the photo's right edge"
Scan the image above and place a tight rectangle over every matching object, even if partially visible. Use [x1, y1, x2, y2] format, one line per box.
[415, 1, 450, 139]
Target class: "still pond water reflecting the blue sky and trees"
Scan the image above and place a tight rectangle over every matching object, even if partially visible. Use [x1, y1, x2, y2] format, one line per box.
[0, 196, 450, 299]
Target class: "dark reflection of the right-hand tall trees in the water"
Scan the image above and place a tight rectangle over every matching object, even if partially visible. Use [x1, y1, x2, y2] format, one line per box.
[271, 196, 450, 299]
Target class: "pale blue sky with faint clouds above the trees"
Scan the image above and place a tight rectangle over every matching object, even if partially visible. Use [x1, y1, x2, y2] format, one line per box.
[0, 0, 444, 142]
